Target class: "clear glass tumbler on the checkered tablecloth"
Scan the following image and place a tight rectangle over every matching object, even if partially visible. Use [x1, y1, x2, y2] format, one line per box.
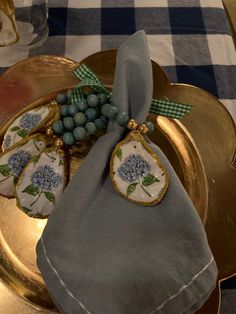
[0, 0, 48, 67]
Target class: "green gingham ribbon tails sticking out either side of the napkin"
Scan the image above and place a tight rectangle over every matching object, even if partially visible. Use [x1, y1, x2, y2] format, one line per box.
[70, 64, 193, 119]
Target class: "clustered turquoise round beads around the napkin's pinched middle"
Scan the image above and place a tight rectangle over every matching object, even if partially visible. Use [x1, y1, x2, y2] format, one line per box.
[52, 91, 154, 146]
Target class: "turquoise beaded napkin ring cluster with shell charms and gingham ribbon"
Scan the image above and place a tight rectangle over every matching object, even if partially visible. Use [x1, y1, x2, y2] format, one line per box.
[0, 64, 192, 218]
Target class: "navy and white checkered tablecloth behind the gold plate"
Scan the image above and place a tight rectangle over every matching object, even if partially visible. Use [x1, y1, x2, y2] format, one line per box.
[0, 0, 236, 116]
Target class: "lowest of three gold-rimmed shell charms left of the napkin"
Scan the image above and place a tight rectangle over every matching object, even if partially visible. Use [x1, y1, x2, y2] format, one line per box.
[16, 148, 66, 218]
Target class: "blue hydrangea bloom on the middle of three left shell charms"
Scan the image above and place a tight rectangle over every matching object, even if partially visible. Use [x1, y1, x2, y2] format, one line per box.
[8, 150, 32, 176]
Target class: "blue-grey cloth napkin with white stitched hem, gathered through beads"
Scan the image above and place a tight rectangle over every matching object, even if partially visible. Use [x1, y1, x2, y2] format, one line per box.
[36, 31, 217, 314]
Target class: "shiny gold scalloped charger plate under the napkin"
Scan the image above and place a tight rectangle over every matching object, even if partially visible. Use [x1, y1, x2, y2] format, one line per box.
[0, 50, 236, 314]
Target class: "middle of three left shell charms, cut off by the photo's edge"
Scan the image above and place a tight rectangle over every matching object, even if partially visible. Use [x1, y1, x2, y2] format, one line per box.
[0, 134, 46, 197]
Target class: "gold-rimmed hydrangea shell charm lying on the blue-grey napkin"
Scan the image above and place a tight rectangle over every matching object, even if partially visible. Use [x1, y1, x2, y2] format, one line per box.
[110, 130, 169, 206]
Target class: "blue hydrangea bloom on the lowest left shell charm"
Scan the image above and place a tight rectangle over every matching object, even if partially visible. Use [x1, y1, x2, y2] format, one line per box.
[31, 165, 62, 191]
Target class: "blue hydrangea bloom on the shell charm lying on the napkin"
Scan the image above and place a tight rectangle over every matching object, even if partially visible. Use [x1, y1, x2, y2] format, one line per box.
[117, 154, 151, 182]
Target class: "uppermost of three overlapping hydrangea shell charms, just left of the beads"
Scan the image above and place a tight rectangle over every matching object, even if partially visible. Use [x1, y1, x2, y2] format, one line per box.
[2, 102, 60, 151]
